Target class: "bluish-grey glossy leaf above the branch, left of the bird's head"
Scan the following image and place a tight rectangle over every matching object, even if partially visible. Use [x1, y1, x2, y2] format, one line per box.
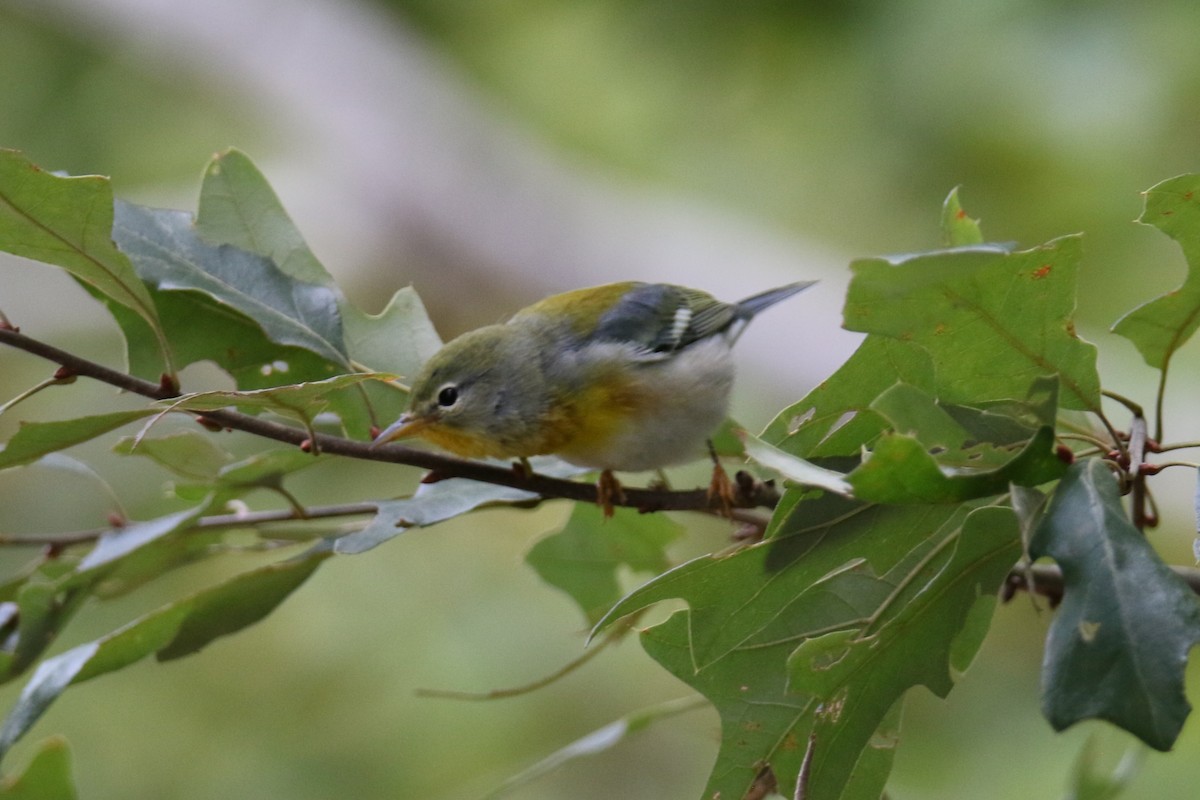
[113, 201, 349, 368]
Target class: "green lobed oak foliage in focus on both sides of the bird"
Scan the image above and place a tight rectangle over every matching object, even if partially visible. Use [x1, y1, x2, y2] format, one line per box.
[0, 151, 1200, 800]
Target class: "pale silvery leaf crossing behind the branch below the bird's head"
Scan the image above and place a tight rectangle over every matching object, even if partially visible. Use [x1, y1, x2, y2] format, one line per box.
[334, 456, 586, 555]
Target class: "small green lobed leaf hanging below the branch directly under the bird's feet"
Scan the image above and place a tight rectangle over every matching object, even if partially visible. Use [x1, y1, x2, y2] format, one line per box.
[526, 503, 683, 625]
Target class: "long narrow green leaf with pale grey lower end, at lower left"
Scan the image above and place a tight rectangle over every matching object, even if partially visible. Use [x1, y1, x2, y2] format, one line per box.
[0, 548, 332, 756]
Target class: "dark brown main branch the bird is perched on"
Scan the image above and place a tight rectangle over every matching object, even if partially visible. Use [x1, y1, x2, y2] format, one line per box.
[0, 325, 779, 513]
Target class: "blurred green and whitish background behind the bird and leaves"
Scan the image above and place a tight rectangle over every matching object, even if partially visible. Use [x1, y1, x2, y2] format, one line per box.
[0, 0, 1200, 800]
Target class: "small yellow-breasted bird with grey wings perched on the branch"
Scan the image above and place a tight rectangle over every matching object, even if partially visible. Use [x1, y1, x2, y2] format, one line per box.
[374, 281, 815, 515]
